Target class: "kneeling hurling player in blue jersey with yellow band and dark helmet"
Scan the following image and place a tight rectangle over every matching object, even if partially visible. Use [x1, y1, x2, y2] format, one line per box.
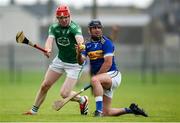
[76, 19, 147, 117]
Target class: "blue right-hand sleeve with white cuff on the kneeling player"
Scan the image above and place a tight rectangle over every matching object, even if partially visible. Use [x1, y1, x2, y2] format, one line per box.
[103, 40, 114, 57]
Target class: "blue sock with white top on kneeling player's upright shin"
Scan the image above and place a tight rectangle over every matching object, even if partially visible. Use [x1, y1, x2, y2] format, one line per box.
[95, 96, 103, 112]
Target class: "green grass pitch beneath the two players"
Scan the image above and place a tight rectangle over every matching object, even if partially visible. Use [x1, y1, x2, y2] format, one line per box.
[0, 72, 180, 122]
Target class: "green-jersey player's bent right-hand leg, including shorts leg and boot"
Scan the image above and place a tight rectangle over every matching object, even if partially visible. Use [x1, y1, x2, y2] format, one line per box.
[60, 63, 88, 115]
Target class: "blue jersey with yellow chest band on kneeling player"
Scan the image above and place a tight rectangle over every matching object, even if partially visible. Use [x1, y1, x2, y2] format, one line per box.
[82, 36, 117, 74]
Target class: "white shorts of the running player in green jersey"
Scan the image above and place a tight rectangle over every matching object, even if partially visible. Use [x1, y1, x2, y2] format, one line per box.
[49, 56, 82, 79]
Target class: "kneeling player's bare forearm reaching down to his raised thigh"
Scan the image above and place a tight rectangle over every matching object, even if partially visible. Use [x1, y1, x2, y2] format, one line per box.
[97, 56, 113, 74]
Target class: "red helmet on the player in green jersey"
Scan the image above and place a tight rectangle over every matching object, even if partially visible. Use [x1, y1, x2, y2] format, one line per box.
[56, 5, 70, 17]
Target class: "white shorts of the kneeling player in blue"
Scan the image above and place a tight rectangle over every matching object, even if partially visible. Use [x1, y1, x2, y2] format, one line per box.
[104, 71, 121, 98]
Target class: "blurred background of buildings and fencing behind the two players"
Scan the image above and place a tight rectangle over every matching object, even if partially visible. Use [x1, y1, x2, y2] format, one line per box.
[0, 0, 180, 82]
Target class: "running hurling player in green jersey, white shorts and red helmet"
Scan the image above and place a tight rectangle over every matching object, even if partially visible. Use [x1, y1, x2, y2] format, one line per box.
[24, 5, 88, 115]
